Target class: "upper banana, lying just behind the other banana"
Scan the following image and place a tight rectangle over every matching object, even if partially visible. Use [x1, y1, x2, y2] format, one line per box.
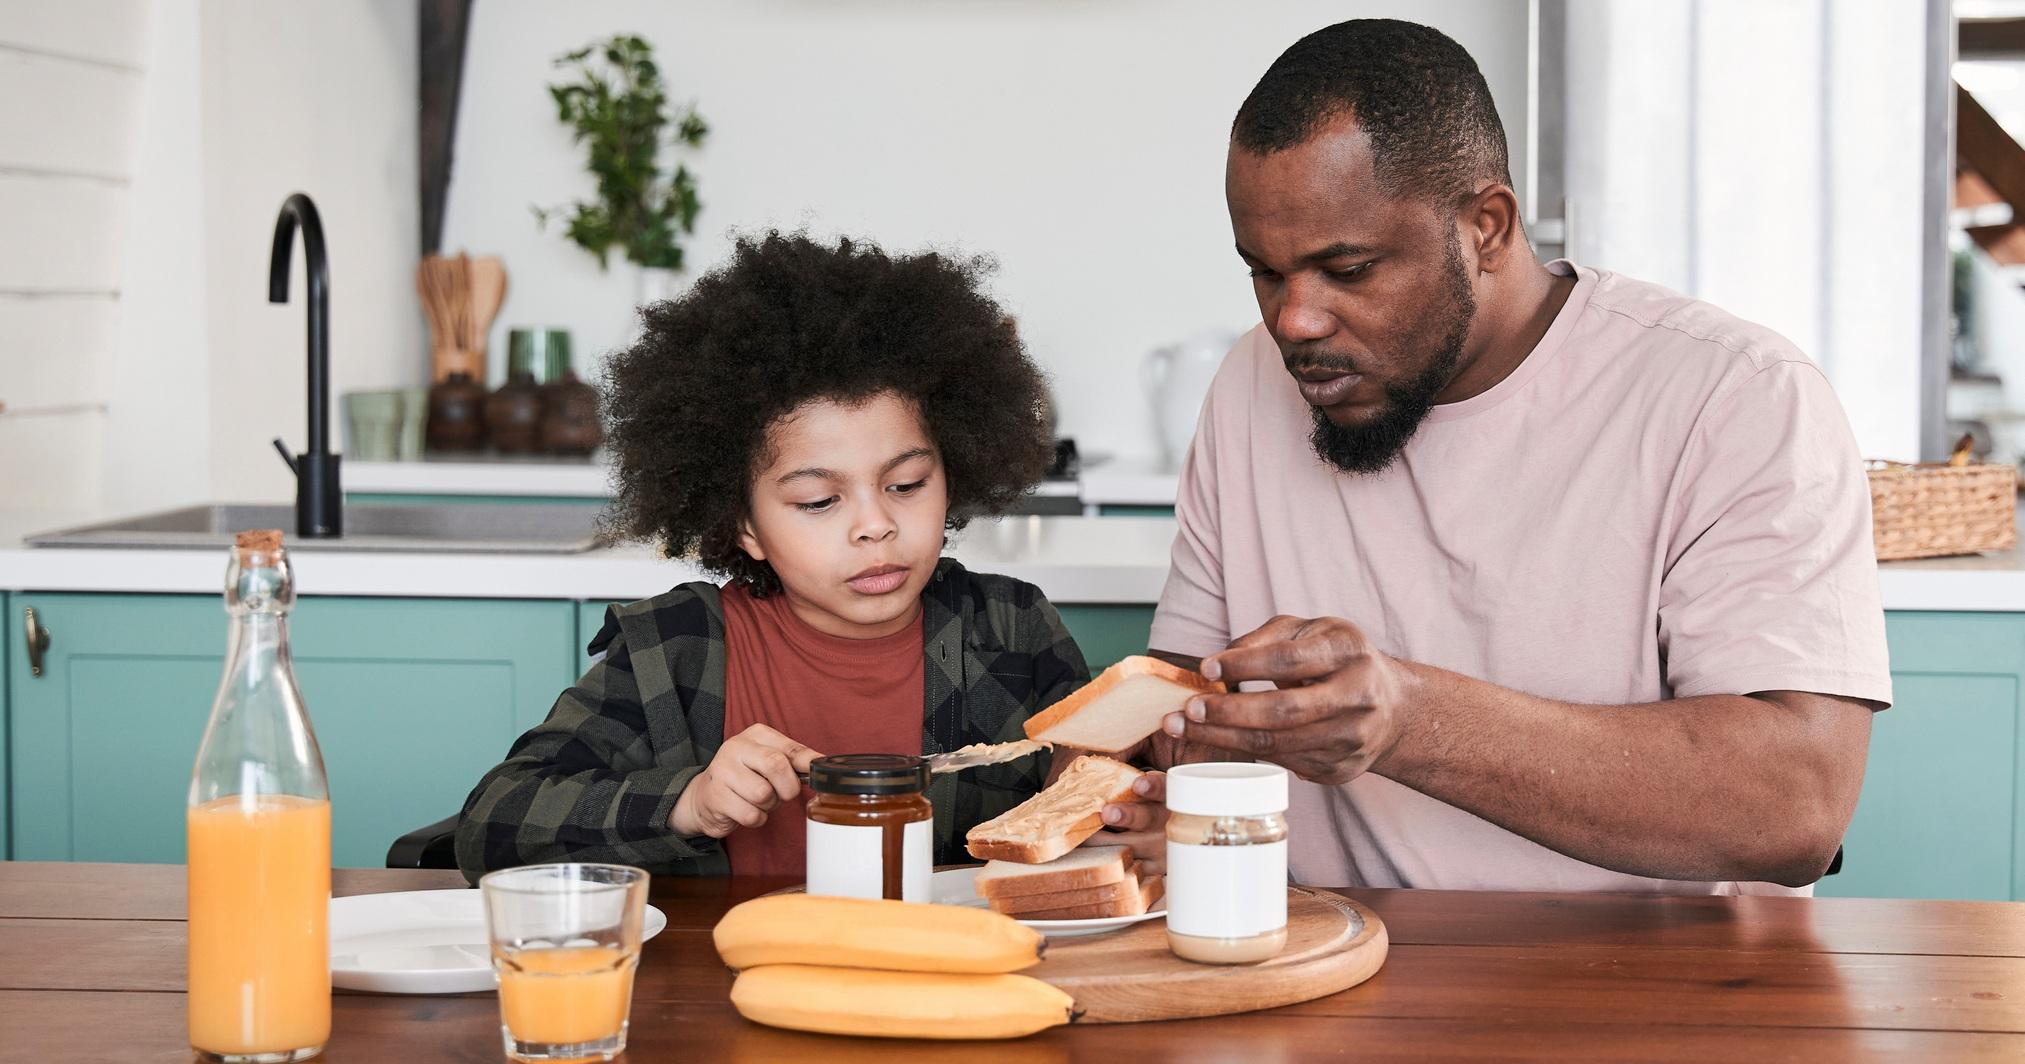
[713, 894, 1047, 973]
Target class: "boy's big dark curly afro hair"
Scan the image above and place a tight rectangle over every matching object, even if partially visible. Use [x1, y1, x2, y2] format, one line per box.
[603, 231, 1053, 594]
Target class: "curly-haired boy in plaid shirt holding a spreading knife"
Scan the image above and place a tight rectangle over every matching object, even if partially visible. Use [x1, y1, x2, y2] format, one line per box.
[456, 233, 1089, 882]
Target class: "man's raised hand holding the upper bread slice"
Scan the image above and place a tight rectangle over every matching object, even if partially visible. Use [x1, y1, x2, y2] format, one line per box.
[1164, 616, 1411, 784]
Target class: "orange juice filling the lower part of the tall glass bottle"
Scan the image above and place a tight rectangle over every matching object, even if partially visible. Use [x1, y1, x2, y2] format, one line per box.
[188, 794, 330, 1056]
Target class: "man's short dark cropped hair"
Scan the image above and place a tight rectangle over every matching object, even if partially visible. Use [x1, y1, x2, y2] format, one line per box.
[1231, 18, 1513, 201]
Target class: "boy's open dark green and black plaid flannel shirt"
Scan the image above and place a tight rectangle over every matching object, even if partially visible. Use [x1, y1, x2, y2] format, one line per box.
[456, 559, 1089, 882]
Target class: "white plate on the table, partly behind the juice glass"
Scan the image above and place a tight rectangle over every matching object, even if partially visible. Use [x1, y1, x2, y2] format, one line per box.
[330, 890, 668, 993]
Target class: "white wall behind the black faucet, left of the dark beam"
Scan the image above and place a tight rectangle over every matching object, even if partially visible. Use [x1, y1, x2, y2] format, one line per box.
[0, 0, 427, 511]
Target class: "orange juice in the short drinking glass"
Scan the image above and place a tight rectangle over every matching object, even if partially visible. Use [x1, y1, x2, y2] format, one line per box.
[492, 946, 638, 1046]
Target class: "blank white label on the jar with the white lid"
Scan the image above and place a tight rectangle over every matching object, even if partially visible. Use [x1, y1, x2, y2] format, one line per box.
[1166, 839, 1286, 938]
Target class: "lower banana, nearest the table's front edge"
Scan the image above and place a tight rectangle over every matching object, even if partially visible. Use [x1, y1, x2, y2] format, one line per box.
[731, 965, 1077, 1038]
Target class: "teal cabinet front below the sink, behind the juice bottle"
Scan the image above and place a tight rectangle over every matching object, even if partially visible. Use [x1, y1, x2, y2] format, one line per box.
[6, 594, 577, 867]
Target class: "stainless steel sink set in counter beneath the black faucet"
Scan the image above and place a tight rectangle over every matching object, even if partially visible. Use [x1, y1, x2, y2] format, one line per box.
[26, 503, 605, 553]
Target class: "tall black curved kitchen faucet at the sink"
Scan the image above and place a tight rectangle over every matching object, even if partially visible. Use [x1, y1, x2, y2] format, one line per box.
[267, 193, 344, 539]
